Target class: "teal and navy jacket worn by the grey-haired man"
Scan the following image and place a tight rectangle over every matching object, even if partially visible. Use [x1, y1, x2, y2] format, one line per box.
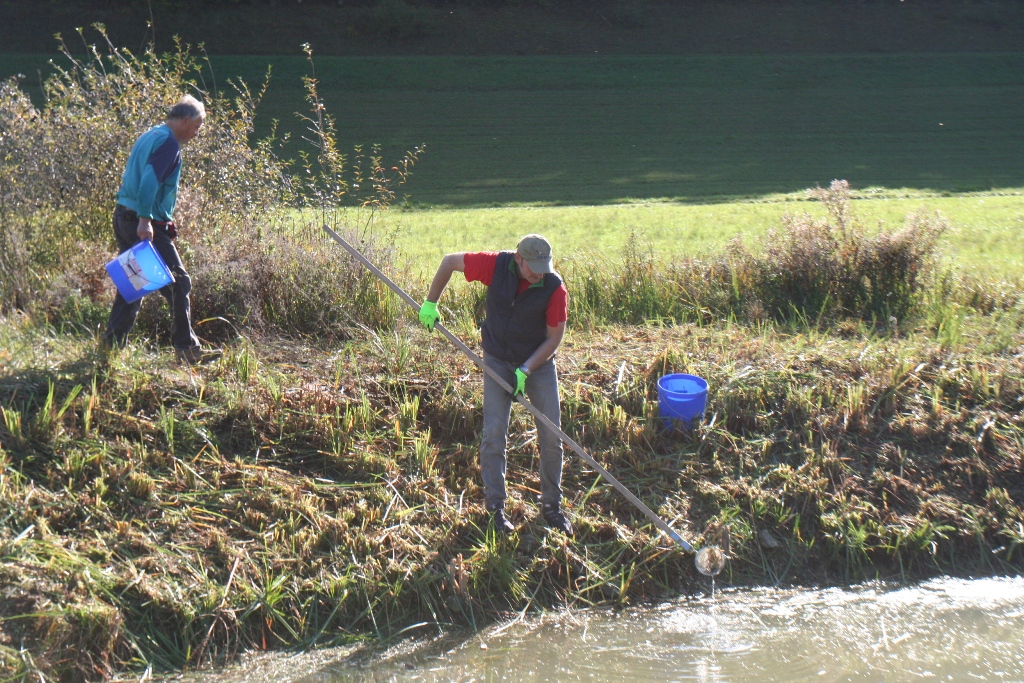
[118, 124, 181, 221]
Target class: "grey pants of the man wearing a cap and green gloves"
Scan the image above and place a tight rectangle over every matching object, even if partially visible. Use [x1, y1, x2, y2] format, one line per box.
[480, 355, 562, 510]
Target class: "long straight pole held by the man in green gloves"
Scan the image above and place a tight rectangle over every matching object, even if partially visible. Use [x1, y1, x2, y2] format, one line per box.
[324, 225, 693, 553]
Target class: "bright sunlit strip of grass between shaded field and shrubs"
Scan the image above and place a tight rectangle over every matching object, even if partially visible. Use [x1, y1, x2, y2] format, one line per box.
[378, 191, 1024, 281]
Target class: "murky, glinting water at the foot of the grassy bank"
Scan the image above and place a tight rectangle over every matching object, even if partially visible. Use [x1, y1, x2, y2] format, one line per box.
[207, 578, 1024, 683]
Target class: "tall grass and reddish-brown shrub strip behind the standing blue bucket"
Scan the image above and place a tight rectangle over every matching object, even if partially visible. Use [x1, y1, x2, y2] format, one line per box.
[512, 180, 946, 325]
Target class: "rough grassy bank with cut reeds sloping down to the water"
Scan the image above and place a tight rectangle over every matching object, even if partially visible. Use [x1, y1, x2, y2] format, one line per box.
[0, 290, 1024, 679]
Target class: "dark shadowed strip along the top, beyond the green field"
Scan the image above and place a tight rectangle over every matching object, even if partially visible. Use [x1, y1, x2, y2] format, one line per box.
[0, 0, 1024, 55]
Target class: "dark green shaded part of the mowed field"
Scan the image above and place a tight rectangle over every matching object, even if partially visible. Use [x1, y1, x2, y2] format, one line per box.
[0, 51, 1024, 207]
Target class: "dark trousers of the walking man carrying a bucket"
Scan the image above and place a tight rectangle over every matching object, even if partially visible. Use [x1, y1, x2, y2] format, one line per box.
[103, 204, 199, 349]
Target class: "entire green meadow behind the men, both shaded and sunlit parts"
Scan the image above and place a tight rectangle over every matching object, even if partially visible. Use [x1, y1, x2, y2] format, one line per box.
[0, 52, 1024, 279]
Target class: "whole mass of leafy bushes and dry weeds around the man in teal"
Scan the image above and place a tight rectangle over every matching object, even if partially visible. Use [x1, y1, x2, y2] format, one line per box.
[0, 26, 417, 334]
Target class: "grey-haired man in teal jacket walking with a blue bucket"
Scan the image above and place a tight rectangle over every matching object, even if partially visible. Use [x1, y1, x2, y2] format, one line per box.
[101, 95, 216, 365]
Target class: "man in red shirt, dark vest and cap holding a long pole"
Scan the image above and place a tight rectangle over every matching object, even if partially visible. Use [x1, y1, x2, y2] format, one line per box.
[420, 234, 572, 536]
